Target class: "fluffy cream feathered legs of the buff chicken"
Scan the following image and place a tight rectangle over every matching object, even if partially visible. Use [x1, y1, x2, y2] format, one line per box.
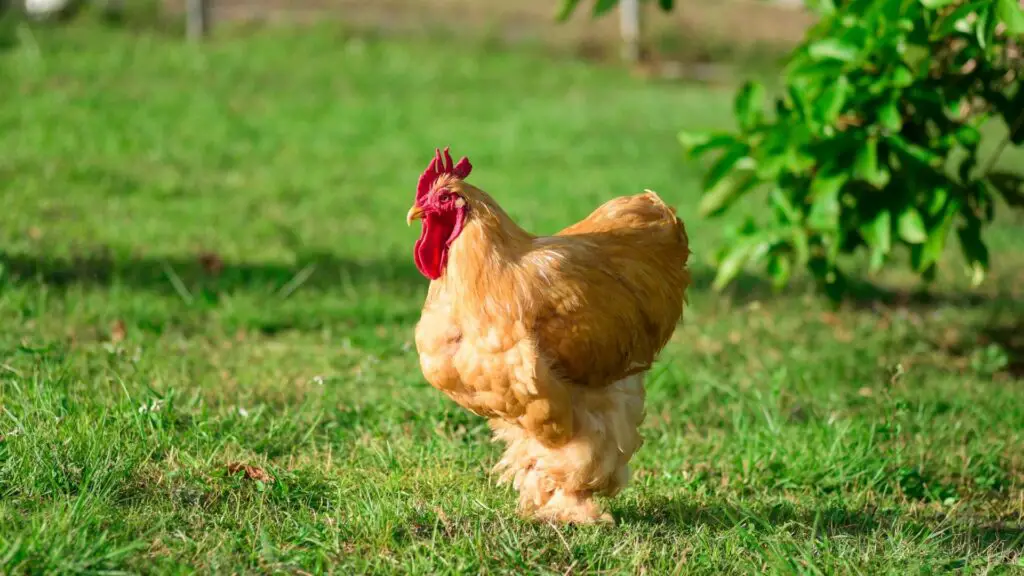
[490, 374, 644, 524]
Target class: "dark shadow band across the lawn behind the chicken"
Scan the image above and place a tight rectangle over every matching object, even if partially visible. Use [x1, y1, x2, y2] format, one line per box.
[0, 250, 1024, 311]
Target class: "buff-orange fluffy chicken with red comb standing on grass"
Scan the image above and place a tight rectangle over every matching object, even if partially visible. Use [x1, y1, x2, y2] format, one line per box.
[407, 148, 690, 524]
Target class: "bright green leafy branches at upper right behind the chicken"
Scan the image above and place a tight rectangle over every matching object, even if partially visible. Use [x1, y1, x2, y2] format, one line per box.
[680, 0, 1024, 298]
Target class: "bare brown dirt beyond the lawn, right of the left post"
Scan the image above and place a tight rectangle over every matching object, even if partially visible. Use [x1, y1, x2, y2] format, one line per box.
[164, 0, 814, 55]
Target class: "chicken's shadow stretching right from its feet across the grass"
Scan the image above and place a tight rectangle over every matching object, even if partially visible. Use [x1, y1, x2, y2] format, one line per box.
[616, 498, 1024, 551]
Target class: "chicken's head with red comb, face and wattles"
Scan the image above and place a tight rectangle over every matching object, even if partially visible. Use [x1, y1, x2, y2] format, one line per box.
[406, 148, 473, 280]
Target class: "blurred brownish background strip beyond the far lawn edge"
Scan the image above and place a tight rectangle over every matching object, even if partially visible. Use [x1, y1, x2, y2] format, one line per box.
[14, 0, 813, 59]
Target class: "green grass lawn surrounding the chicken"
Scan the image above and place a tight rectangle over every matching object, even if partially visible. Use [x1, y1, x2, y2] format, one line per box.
[0, 20, 1024, 574]
